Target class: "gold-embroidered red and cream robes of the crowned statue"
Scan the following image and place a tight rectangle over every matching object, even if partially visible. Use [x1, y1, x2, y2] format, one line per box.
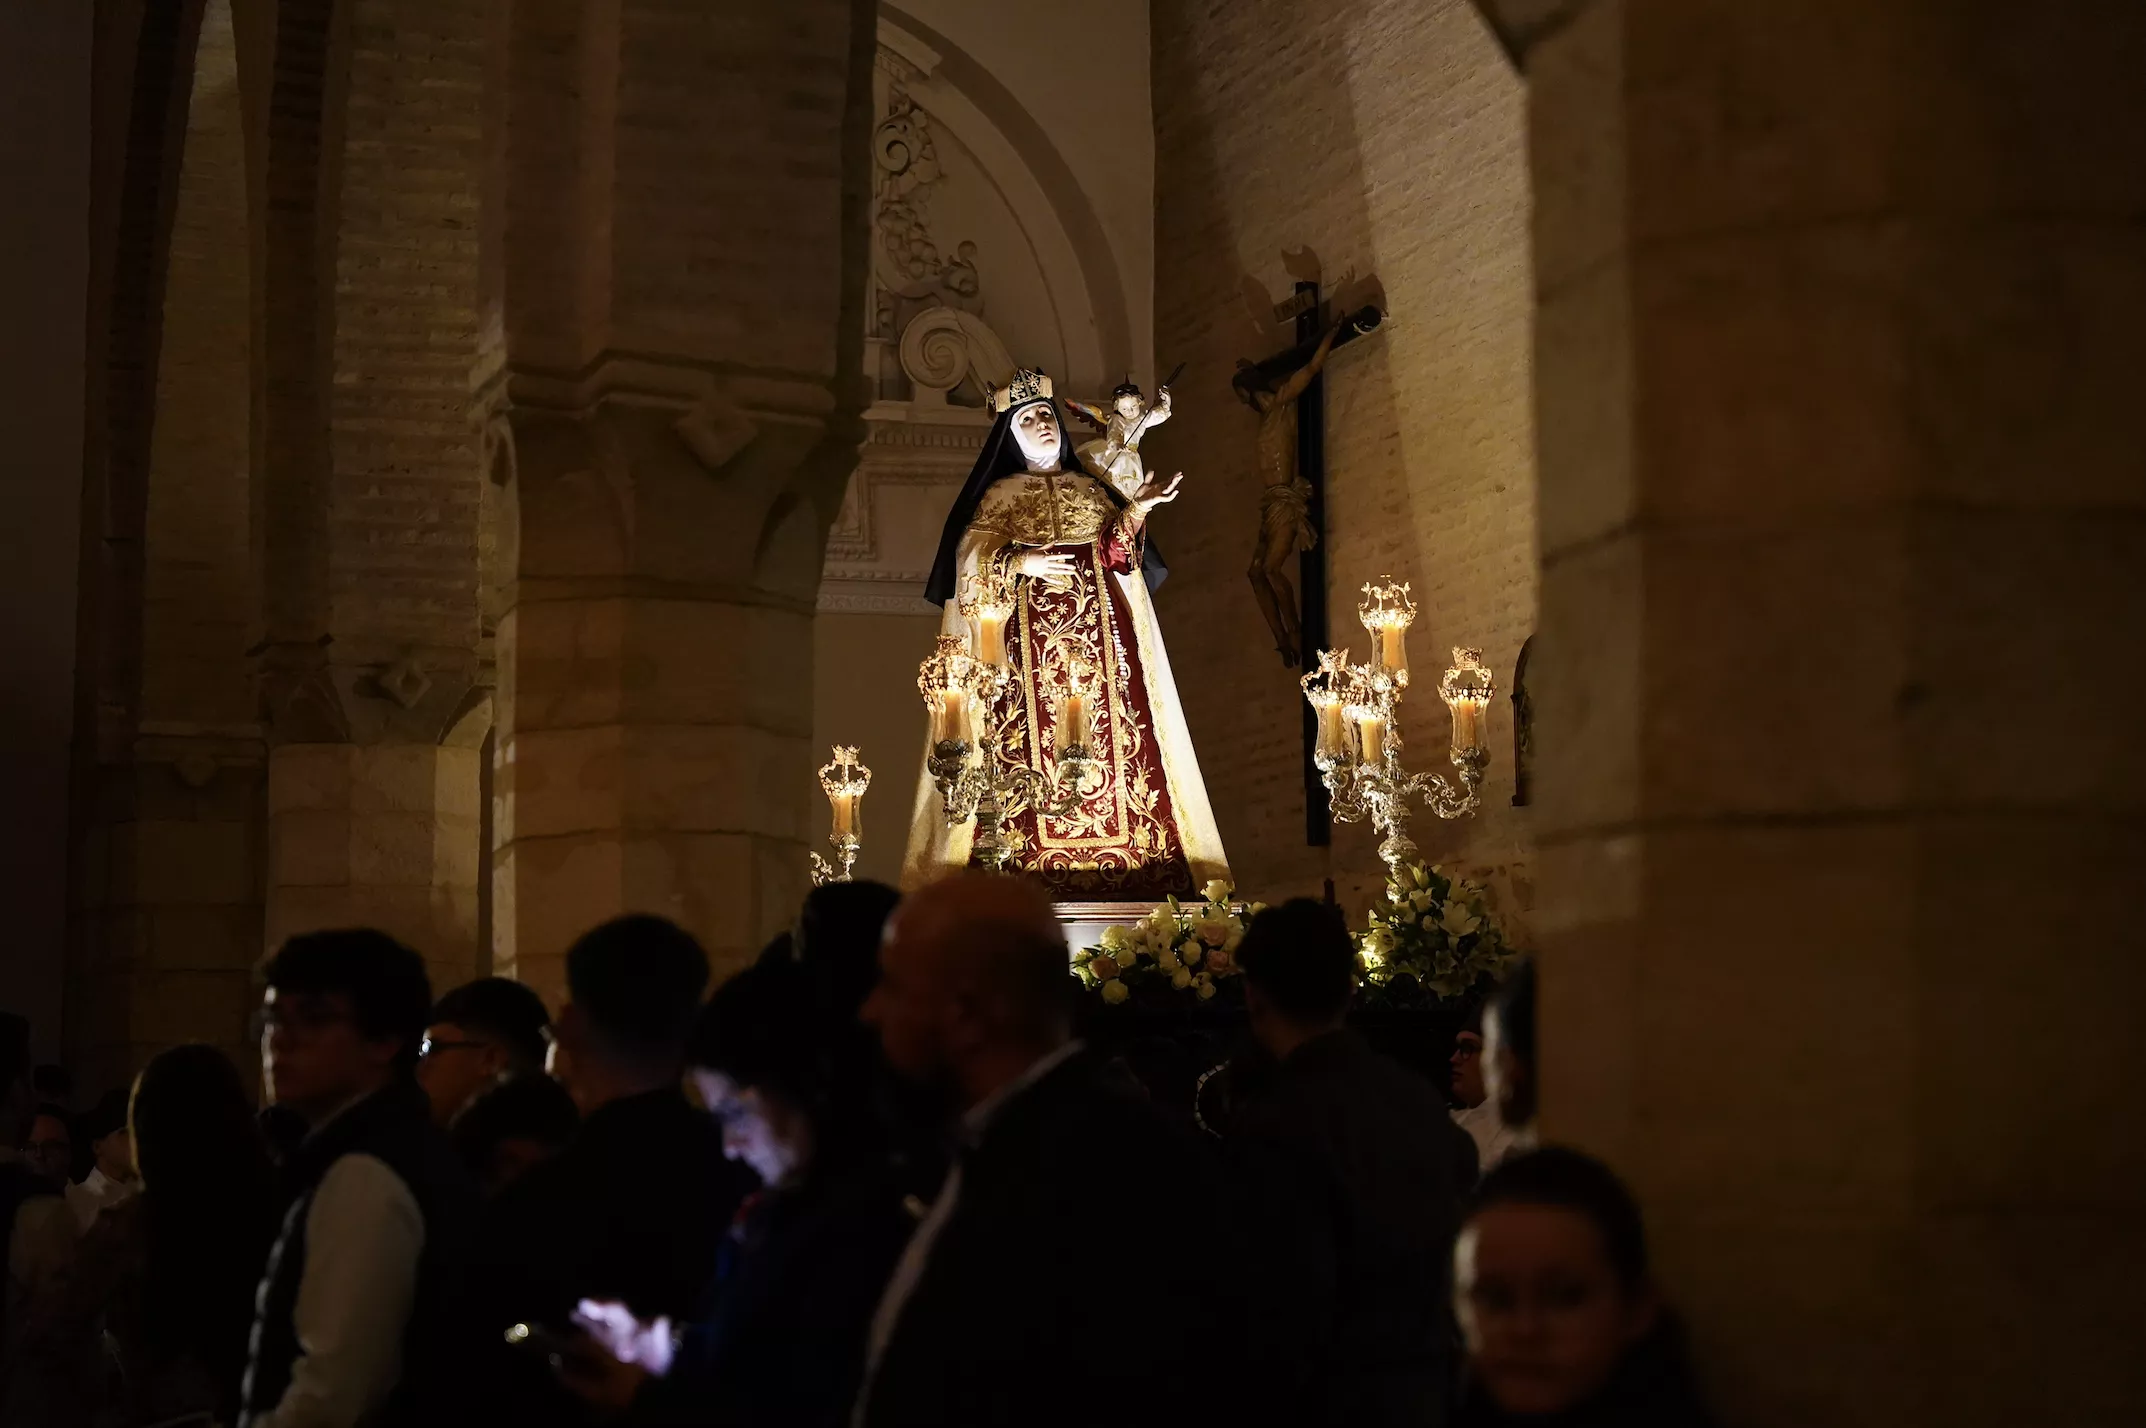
[901, 461, 1230, 902]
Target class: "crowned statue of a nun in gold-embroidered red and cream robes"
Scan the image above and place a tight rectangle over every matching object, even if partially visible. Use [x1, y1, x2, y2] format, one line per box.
[901, 371, 1230, 902]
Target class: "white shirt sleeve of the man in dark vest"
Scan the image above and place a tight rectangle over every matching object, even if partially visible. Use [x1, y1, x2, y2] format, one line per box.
[253, 1155, 425, 1428]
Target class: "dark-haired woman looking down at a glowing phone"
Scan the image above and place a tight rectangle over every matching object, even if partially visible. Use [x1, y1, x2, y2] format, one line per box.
[560, 958, 914, 1428]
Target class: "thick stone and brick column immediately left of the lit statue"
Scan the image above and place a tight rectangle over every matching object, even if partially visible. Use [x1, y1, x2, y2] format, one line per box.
[494, 0, 876, 996]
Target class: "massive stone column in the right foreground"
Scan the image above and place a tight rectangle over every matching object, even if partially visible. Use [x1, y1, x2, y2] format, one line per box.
[1528, 0, 2146, 1428]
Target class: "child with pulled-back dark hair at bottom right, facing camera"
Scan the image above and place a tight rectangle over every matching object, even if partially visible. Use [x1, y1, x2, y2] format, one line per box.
[1453, 1147, 1713, 1428]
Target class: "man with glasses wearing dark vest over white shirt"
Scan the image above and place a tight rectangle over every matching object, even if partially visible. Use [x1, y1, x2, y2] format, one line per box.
[240, 928, 474, 1428]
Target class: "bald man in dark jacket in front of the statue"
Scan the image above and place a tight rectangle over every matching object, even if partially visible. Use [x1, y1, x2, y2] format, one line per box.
[854, 874, 1285, 1428]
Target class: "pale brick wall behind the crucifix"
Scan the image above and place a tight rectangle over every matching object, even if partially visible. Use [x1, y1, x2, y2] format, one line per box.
[1146, 0, 1534, 917]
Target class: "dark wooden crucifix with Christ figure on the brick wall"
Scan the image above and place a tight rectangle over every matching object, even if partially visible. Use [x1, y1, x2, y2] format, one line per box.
[1232, 281, 1380, 848]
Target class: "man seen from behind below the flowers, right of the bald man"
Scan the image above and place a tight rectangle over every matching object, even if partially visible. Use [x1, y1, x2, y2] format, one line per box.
[1230, 898, 1476, 1428]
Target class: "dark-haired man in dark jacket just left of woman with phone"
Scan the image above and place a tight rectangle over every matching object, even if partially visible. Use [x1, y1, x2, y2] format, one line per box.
[464, 915, 753, 1424]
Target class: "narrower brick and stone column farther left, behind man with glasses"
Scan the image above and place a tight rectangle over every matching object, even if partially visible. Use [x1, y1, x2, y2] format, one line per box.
[255, 0, 498, 990]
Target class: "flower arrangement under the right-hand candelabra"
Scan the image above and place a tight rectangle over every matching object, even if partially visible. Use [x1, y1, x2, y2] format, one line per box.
[1356, 863, 1517, 1003]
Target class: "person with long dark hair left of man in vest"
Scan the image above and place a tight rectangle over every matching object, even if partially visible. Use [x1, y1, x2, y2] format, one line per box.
[43, 1046, 275, 1424]
